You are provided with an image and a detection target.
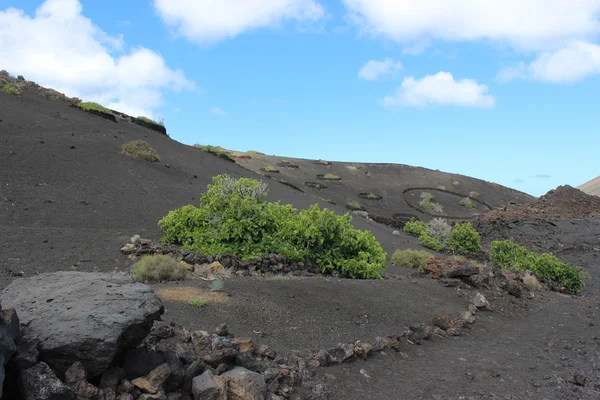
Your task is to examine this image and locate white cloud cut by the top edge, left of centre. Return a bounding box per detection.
[154,0,325,44]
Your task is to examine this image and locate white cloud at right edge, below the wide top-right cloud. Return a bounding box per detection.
[497,42,600,83]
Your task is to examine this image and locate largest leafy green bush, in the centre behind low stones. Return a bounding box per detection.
[158,175,386,278]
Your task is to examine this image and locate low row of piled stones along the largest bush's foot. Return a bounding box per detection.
[121,239,326,276]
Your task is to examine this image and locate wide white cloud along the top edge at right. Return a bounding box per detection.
[342,0,600,50]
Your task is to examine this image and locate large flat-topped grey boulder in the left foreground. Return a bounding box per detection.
[2,271,164,379]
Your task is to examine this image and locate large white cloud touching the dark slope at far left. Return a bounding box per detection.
[0,0,193,116]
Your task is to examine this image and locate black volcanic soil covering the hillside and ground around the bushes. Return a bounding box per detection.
[0,84,600,400]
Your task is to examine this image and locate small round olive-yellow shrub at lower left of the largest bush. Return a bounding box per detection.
[131,254,188,282]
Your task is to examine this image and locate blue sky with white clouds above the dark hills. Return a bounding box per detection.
[0,0,600,196]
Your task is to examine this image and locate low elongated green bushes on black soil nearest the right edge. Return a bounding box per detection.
[490,240,586,293]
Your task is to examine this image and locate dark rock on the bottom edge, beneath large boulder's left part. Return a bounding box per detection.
[20,362,75,400]
